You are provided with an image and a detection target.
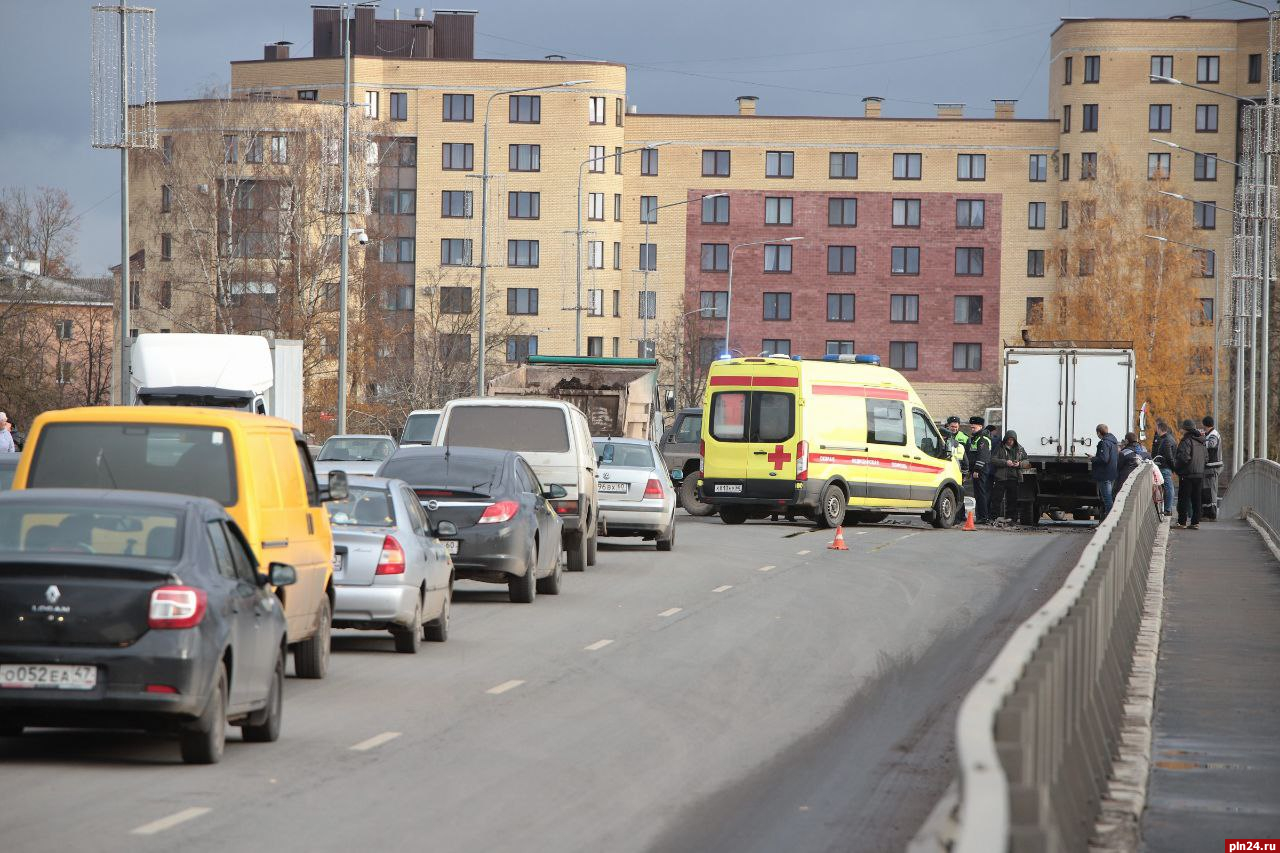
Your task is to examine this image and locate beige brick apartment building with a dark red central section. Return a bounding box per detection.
[122,8,1266,422]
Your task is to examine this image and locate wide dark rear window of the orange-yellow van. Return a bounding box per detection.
[27,424,236,506]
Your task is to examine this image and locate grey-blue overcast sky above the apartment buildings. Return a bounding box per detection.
[0,0,1258,275]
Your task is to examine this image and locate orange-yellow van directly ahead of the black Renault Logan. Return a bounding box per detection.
[13,406,346,679]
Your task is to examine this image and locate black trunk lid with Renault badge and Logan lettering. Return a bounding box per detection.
[0,562,169,646]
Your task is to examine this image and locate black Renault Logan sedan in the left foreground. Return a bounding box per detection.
[0,489,297,765]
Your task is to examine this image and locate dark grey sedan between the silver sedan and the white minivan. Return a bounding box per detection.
[378,446,564,603]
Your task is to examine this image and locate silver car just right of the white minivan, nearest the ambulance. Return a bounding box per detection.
[593,438,676,551]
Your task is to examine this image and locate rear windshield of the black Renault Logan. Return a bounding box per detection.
[0,502,182,562]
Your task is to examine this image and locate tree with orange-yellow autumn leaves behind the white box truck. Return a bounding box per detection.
[1034,152,1220,423]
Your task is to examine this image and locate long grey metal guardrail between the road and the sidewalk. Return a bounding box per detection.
[950,462,1162,853]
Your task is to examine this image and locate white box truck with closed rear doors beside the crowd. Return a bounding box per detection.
[995,341,1137,524]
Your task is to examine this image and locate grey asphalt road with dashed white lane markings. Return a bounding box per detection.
[0,515,1088,853]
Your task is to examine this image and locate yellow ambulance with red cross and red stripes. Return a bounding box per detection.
[699,355,964,528]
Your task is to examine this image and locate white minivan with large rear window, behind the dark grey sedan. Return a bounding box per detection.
[435,397,600,571]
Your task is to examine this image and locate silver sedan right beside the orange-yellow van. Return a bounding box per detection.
[325,476,453,654]
